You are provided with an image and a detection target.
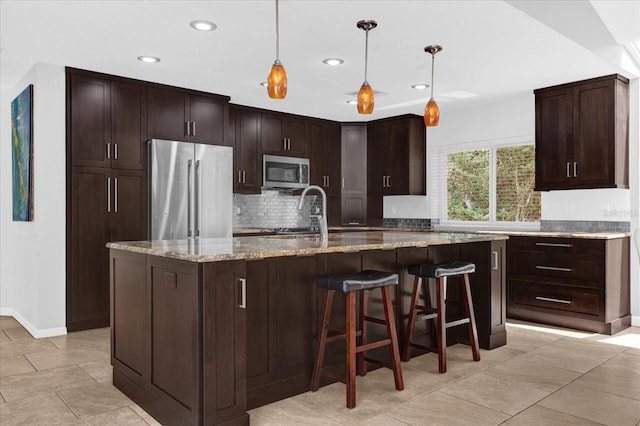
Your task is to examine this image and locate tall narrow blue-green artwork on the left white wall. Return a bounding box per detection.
[11,84,33,221]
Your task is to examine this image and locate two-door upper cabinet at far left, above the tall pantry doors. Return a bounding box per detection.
[67,73,147,170]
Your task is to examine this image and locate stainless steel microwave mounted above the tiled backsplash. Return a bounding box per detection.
[262,155,309,189]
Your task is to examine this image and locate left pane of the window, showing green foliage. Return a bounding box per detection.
[447,149,489,221]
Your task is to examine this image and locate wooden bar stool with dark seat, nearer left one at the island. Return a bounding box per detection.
[311,270,404,408]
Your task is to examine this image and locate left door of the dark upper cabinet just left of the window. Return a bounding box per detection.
[367,123,389,195]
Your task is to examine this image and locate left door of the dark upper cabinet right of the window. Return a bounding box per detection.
[535,88,573,191]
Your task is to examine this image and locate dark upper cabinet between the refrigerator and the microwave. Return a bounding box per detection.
[229,106,262,194]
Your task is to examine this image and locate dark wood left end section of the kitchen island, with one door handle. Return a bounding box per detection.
[110,250,249,425]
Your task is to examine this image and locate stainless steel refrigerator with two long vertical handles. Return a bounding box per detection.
[148,139,233,240]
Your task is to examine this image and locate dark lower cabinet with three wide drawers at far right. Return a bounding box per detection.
[507,237,631,334]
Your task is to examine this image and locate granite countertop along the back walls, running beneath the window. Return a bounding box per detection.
[233,226,630,240]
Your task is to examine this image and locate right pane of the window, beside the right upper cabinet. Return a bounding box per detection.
[496,145,540,222]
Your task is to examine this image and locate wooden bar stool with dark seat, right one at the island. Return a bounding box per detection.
[402,261,480,373]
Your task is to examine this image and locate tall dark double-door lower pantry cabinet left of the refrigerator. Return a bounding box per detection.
[67,167,147,331]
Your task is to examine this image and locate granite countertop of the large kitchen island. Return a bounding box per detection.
[107,231,508,263]
